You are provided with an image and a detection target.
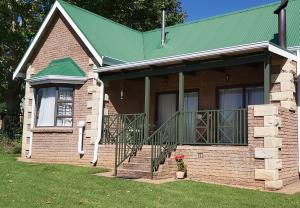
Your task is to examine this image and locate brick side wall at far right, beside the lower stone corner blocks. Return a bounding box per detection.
[279,107,299,185]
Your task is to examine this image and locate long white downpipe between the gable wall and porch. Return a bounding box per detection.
[91,73,104,165]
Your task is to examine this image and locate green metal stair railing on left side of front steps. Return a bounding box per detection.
[109,113,145,175]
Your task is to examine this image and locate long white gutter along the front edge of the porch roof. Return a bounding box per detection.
[95,41,269,73]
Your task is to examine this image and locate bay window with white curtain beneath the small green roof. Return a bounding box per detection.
[36,87,73,127]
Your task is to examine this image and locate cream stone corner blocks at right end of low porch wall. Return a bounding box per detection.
[254,104,283,190]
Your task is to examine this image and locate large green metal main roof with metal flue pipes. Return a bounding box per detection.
[58,0,300,62]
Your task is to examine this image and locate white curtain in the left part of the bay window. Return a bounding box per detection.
[37,87,56,126]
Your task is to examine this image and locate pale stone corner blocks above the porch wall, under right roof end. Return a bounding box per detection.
[270,59,296,111]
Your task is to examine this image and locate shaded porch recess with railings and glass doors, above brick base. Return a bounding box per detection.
[102,51,270,178]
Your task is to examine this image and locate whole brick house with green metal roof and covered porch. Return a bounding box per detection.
[14,0,300,190]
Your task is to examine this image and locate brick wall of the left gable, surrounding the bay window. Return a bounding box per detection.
[24,15,114,167]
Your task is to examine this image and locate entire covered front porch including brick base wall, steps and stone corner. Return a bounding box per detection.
[96,46,294,188]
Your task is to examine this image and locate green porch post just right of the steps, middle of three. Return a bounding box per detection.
[178,72,184,144]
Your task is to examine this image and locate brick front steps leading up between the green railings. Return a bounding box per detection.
[117,146,176,179]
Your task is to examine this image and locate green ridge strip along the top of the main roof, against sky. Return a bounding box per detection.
[144,0,286,33]
